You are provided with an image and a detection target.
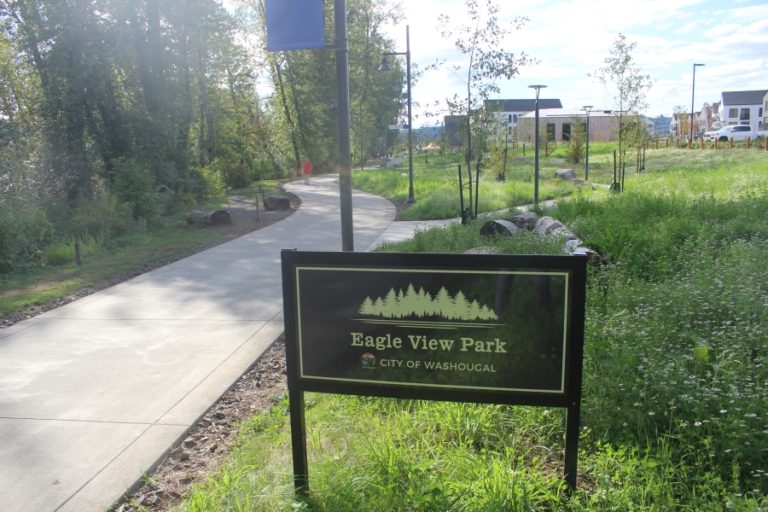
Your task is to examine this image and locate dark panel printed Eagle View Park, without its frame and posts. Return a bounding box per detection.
[295,265,570,394]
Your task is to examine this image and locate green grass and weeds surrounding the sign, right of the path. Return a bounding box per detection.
[172,149,768,512]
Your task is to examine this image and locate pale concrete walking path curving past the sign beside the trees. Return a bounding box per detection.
[0,176,448,512]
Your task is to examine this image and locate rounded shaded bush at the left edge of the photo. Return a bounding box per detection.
[0,200,53,272]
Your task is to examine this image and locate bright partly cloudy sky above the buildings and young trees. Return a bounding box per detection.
[225,0,768,126]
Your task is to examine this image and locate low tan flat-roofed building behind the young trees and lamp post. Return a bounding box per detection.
[517,108,619,142]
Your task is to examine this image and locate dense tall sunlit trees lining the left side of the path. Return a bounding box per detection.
[0,0,404,270]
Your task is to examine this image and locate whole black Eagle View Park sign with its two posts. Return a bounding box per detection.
[282,251,586,488]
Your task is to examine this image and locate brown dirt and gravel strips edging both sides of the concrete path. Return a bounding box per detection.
[0,194,300,512]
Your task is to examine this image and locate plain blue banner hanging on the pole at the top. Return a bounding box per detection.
[265,0,325,52]
